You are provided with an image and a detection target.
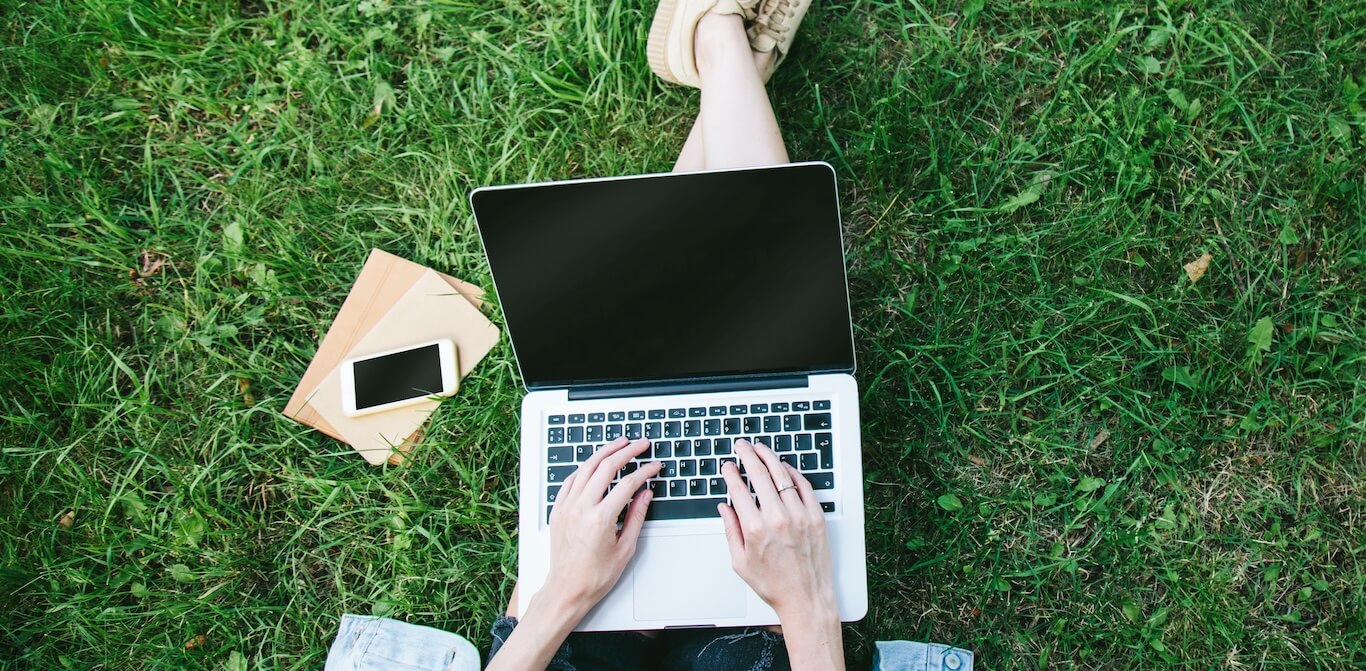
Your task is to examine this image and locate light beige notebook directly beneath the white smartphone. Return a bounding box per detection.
[307,271,499,465]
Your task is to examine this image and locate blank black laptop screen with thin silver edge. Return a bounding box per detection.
[471,163,854,388]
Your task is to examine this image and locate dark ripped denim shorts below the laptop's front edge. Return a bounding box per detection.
[489,616,792,671]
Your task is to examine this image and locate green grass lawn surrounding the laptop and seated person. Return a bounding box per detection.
[0,0,1366,670]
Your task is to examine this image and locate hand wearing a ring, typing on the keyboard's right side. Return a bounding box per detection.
[717,440,839,620]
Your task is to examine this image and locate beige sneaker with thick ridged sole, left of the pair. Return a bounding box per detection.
[645,0,759,87]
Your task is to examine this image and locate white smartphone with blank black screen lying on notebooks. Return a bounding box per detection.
[342,340,460,417]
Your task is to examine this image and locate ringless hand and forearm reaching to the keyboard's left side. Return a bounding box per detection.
[486,439,660,671]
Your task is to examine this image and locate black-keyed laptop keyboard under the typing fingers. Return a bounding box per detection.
[545,399,835,519]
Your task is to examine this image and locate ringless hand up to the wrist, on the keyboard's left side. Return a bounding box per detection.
[545,437,661,610]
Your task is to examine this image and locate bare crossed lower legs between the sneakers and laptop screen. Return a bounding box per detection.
[673,14,788,172]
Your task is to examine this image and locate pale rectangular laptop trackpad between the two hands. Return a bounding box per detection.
[634,533,750,620]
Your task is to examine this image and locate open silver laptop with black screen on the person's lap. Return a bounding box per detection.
[470,163,867,631]
